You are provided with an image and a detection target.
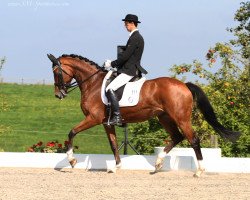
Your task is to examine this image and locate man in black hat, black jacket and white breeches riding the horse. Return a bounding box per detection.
[104,14,147,125]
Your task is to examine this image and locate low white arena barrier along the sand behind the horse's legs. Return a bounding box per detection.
[0,147,250,173]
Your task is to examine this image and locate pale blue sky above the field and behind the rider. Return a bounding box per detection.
[0,0,242,83]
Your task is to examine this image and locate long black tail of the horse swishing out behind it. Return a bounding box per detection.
[186,82,240,142]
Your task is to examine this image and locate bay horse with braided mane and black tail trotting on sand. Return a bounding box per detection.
[48,54,240,177]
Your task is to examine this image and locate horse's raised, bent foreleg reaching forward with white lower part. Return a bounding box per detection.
[67,116,98,168]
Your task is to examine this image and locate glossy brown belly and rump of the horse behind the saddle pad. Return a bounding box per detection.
[121,77,193,122]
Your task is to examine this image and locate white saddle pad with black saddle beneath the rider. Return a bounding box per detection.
[101,71,146,107]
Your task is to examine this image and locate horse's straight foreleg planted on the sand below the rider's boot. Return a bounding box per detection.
[104,125,121,172]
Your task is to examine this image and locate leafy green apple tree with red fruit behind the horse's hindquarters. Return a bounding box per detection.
[132,2,250,156]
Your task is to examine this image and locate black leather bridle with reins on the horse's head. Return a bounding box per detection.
[52,61,102,95]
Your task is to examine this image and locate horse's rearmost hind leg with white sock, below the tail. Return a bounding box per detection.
[180,122,205,177]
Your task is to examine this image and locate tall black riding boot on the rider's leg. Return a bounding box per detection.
[107,89,122,126]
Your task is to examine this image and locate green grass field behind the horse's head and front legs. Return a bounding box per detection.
[0,83,133,154]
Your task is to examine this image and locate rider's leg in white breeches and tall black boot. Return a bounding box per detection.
[106,73,133,126]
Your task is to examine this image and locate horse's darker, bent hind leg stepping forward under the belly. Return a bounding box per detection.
[155,114,184,171]
